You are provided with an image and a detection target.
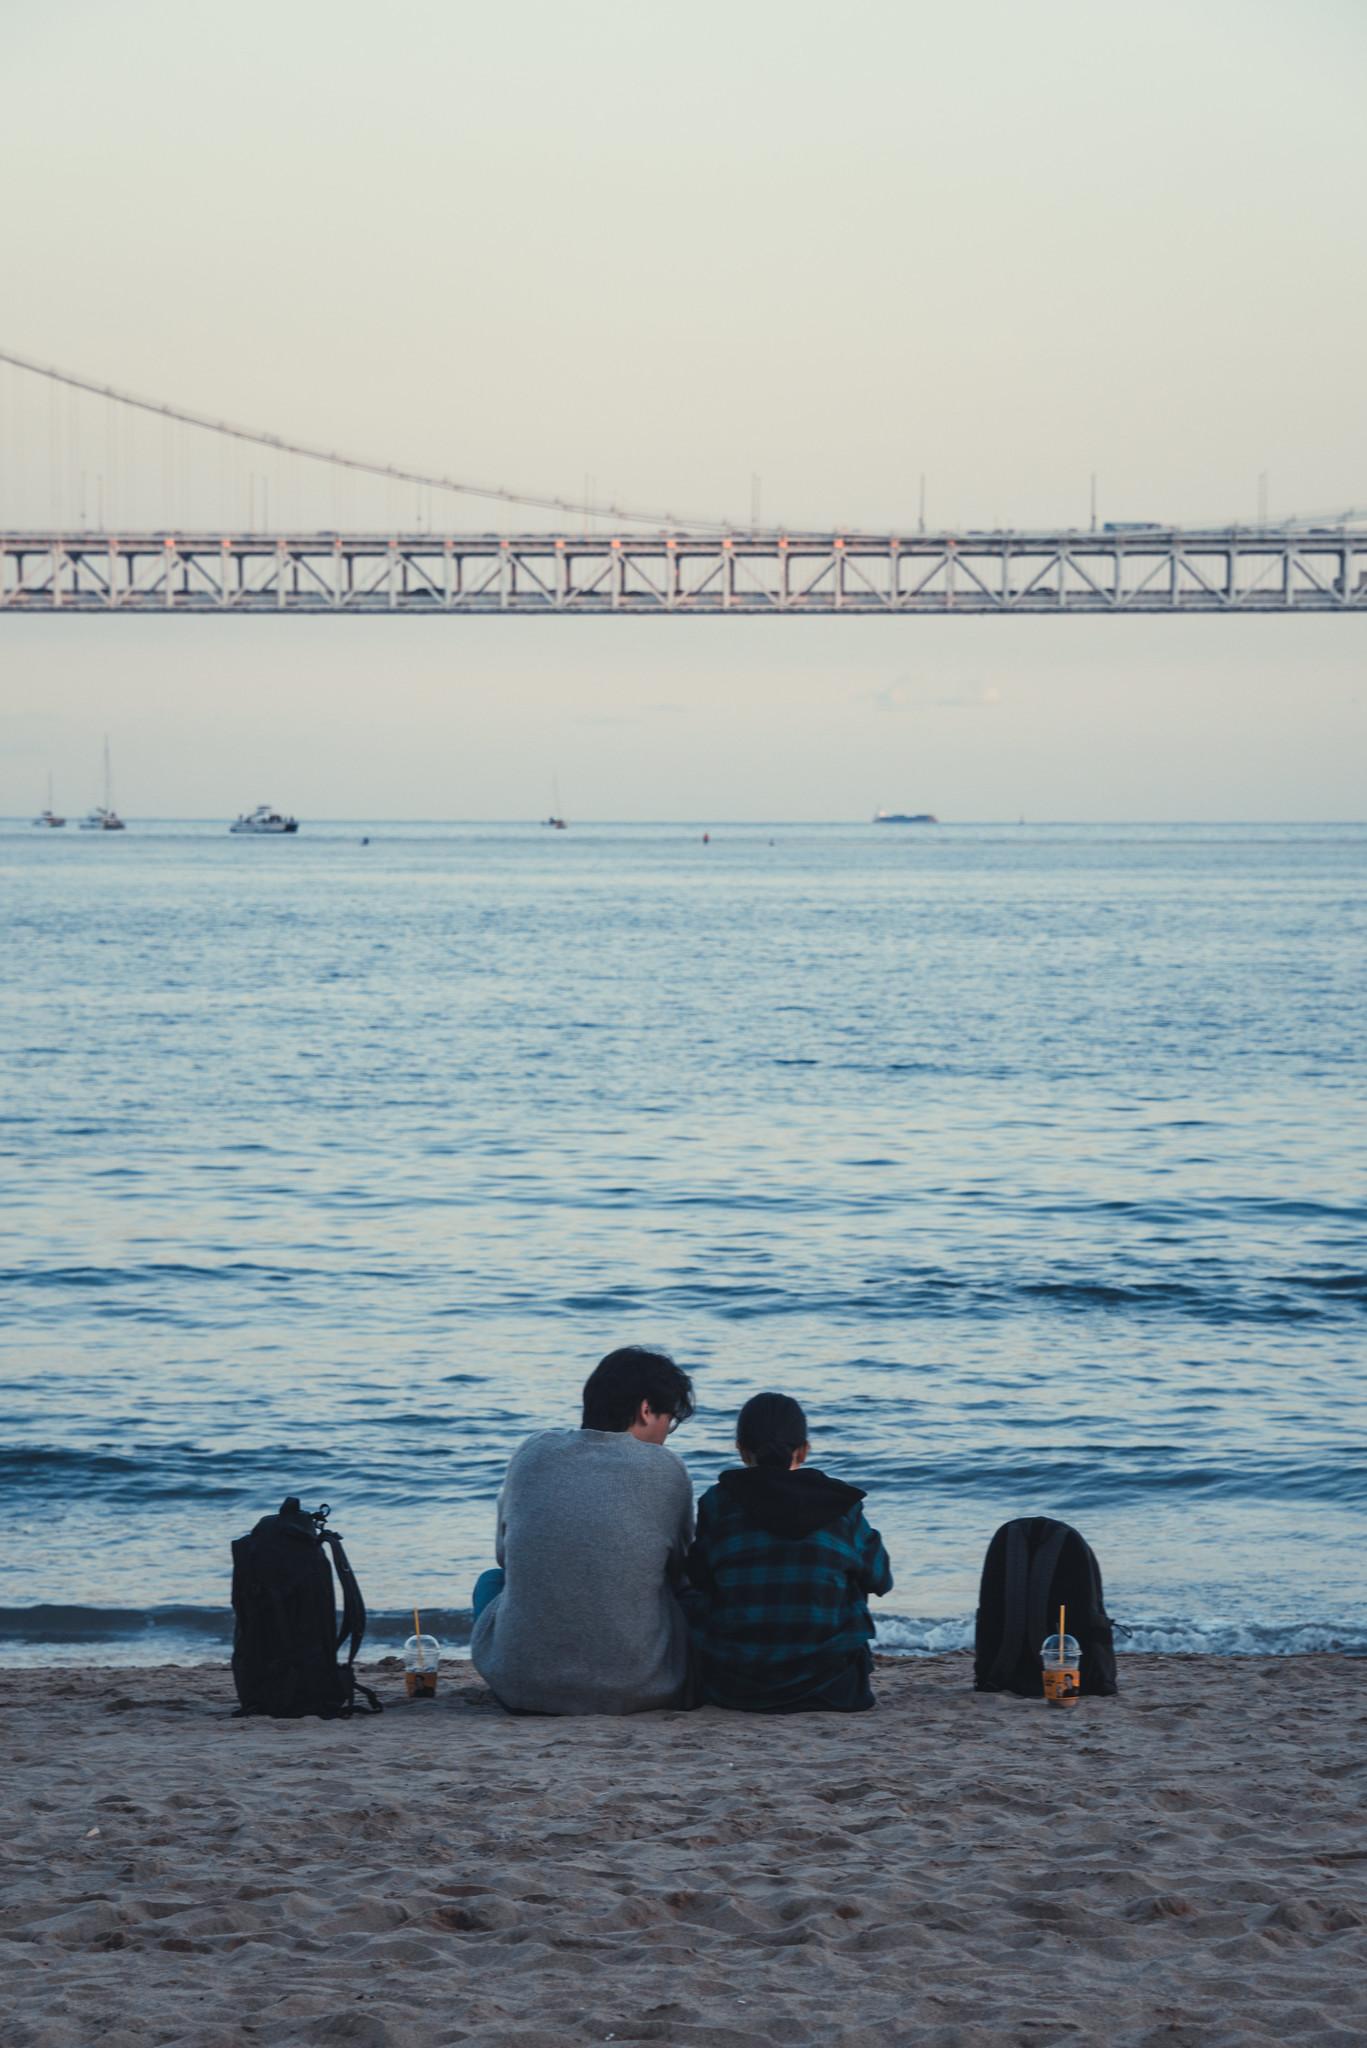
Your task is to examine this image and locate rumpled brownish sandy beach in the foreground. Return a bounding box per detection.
[0,1657,1367,2048]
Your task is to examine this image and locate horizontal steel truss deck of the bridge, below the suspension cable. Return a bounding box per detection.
[0,528,1367,618]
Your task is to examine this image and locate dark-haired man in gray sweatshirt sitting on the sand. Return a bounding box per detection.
[469,1346,693,1714]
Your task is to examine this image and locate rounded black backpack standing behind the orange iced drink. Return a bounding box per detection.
[974,1516,1119,1700]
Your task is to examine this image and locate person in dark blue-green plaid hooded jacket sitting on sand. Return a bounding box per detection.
[687,1395,892,1714]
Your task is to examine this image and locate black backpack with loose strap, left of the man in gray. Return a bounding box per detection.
[232,1493,381,1720]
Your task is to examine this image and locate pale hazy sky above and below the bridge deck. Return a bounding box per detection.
[0,0,1367,819]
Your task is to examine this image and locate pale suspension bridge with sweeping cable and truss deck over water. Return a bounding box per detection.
[0,350,1367,618]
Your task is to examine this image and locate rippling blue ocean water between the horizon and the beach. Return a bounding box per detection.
[0,821,1367,1663]
